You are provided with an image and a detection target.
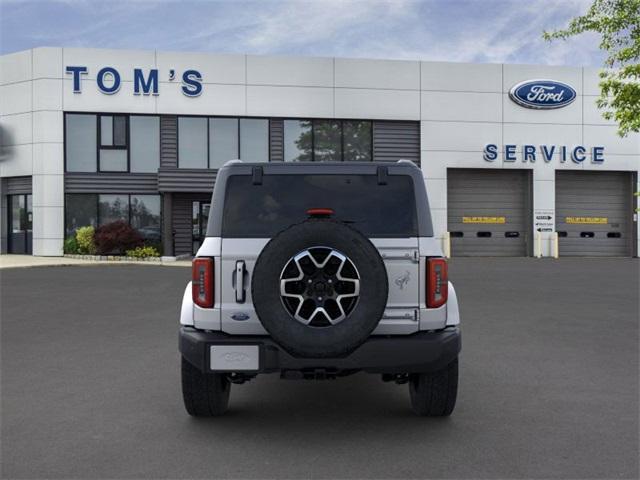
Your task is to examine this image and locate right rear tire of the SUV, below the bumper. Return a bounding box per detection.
[409,357,458,417]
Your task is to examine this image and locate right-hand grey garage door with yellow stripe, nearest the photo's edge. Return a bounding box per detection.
[556,171,633,257]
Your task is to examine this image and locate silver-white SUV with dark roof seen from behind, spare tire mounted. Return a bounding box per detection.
[180,161,461,416]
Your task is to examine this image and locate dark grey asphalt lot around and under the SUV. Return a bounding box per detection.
[0,259,640,479]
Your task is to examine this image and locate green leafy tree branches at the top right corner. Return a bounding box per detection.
[543,0,640,136]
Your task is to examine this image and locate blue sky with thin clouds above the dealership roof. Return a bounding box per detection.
[0,0,604,66]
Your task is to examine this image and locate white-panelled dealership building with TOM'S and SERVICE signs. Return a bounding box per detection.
[0,48,640,257]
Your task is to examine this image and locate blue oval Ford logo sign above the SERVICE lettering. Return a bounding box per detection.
[509,80,576,110]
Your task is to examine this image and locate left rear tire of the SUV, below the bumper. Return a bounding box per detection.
[182,357,231,417]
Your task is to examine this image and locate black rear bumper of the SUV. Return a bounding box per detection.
[180,327,461,374]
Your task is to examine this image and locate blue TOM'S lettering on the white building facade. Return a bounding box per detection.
[65,65,202,97]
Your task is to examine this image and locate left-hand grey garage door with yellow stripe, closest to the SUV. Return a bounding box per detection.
[447,169,531,257]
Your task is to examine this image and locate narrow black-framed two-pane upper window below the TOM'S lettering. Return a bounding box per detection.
[99,115,128,172]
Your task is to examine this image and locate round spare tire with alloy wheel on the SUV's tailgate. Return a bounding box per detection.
[251,219,388,358]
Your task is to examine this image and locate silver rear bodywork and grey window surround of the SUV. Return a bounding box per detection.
[180,162,460,342]
